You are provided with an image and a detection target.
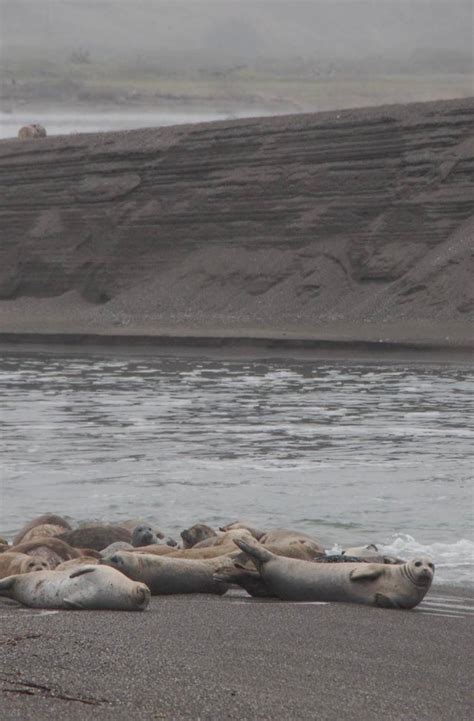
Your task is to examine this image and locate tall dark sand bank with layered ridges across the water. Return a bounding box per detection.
[0,99,474,347]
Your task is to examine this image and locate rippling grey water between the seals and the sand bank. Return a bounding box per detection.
[0,351,474,584]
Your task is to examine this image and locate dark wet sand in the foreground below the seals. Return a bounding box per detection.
[0,587,474,721]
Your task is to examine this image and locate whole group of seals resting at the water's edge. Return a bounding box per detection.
[0,514,434,610]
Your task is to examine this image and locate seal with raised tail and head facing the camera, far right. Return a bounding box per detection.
[236,540,434,608]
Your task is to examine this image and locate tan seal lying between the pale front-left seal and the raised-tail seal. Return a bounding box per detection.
[100,551,232,595]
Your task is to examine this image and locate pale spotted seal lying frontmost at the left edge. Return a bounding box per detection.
[0,566,150,611]
